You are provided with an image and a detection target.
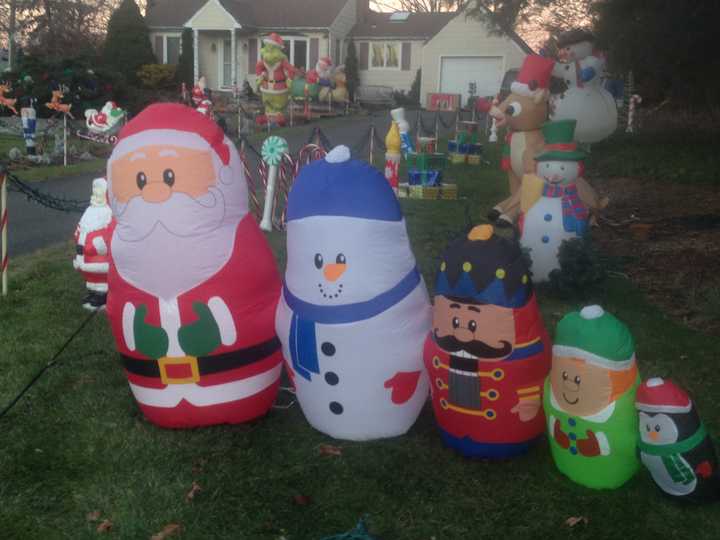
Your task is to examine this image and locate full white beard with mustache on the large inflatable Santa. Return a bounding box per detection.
[111,188,239,300]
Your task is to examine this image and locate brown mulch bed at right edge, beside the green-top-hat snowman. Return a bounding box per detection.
[593,178,720,335]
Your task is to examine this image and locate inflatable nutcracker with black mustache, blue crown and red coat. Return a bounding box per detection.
[424,225,551,458]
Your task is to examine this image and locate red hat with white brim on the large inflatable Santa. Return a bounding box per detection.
[113,103,230,166]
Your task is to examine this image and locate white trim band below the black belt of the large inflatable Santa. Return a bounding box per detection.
[129,364,282,408]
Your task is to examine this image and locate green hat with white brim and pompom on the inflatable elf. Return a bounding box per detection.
[553,306,635,371]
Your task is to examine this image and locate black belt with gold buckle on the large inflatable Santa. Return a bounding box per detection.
[120,336,280,384]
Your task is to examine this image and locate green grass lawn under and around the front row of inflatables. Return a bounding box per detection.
[0,130,720,540]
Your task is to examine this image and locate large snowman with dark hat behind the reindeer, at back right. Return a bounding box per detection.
[550,30,617,143]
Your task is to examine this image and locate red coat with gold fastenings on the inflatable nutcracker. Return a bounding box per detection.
[423,296,552,444]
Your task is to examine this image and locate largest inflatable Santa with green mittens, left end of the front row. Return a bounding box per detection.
[107,103,282,428]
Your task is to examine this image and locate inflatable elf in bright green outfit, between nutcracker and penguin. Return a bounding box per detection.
[543,306,640,489]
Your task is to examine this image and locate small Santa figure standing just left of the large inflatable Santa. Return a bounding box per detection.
[73,178,114,311]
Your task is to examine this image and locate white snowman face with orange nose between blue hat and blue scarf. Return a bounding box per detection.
[285,216,415,306]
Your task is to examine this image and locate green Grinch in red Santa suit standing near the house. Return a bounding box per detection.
[255,32,295,125]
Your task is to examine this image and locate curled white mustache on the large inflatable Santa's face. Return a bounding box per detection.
[110,187,225,242]
